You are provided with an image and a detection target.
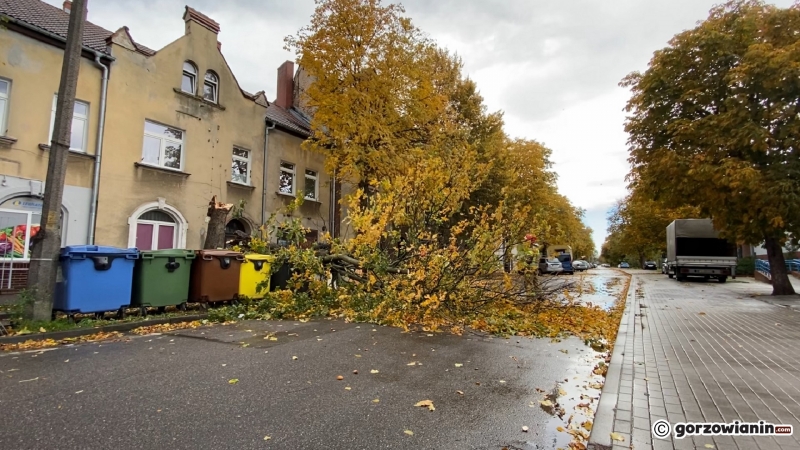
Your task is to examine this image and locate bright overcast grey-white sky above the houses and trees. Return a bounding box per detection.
[46,0,791,250]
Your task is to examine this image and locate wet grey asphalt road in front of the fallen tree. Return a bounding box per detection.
[0,272,624,450]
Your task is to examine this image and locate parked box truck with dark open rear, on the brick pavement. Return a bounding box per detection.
[666,219,737,283]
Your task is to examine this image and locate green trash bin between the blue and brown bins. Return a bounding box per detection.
[131,249,195,316]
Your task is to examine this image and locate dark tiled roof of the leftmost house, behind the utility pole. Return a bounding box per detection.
[0,0,155,56]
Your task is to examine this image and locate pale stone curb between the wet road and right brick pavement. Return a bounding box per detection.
[587,275,636,450]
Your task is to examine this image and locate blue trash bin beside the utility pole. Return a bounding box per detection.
[53,245,139,317]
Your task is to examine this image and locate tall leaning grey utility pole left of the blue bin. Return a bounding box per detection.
[28,0,87,321]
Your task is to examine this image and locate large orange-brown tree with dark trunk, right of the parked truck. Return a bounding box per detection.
[622,0,800,294]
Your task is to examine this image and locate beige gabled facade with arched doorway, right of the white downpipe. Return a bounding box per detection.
[97,9,329,248]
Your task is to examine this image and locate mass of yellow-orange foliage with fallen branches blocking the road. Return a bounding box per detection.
[241,0,610,334]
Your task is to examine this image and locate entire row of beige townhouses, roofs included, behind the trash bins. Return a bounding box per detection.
[0,0,333,296]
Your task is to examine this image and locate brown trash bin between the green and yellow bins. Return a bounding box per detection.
[189,250,244,303]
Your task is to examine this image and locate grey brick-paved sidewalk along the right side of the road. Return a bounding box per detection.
[590,273,800,450]
